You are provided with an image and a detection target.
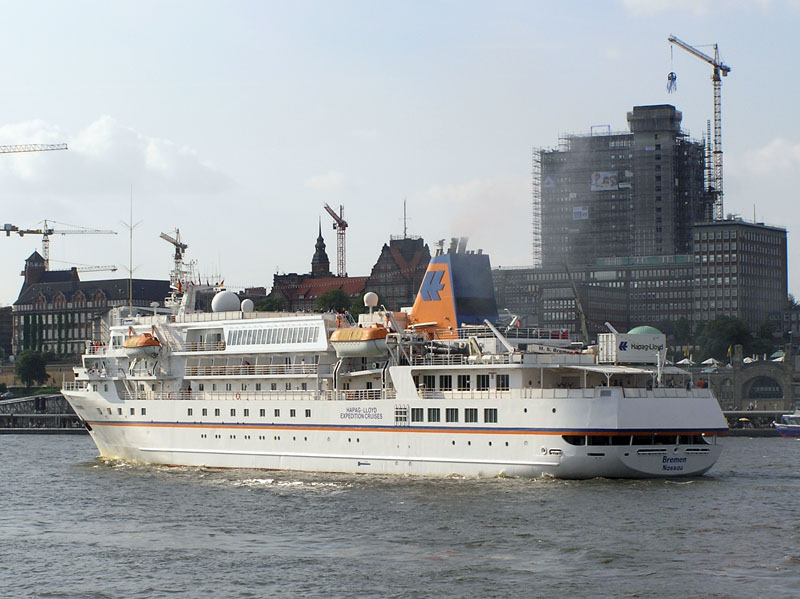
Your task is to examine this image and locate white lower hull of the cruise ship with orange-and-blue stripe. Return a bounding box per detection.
[64,391,721,479]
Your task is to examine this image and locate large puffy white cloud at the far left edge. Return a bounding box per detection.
[0,116,235,195]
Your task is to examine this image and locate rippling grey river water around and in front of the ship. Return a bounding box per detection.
[0,435,800,599]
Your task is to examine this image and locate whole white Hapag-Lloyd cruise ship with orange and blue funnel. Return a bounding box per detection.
[62,239,728,478]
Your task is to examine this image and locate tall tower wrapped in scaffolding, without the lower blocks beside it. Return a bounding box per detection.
[534,105,714,267]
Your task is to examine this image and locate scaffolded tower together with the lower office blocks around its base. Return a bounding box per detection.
[494,105,787,336]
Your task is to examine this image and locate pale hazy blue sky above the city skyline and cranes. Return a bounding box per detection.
[0,0,800,306]
